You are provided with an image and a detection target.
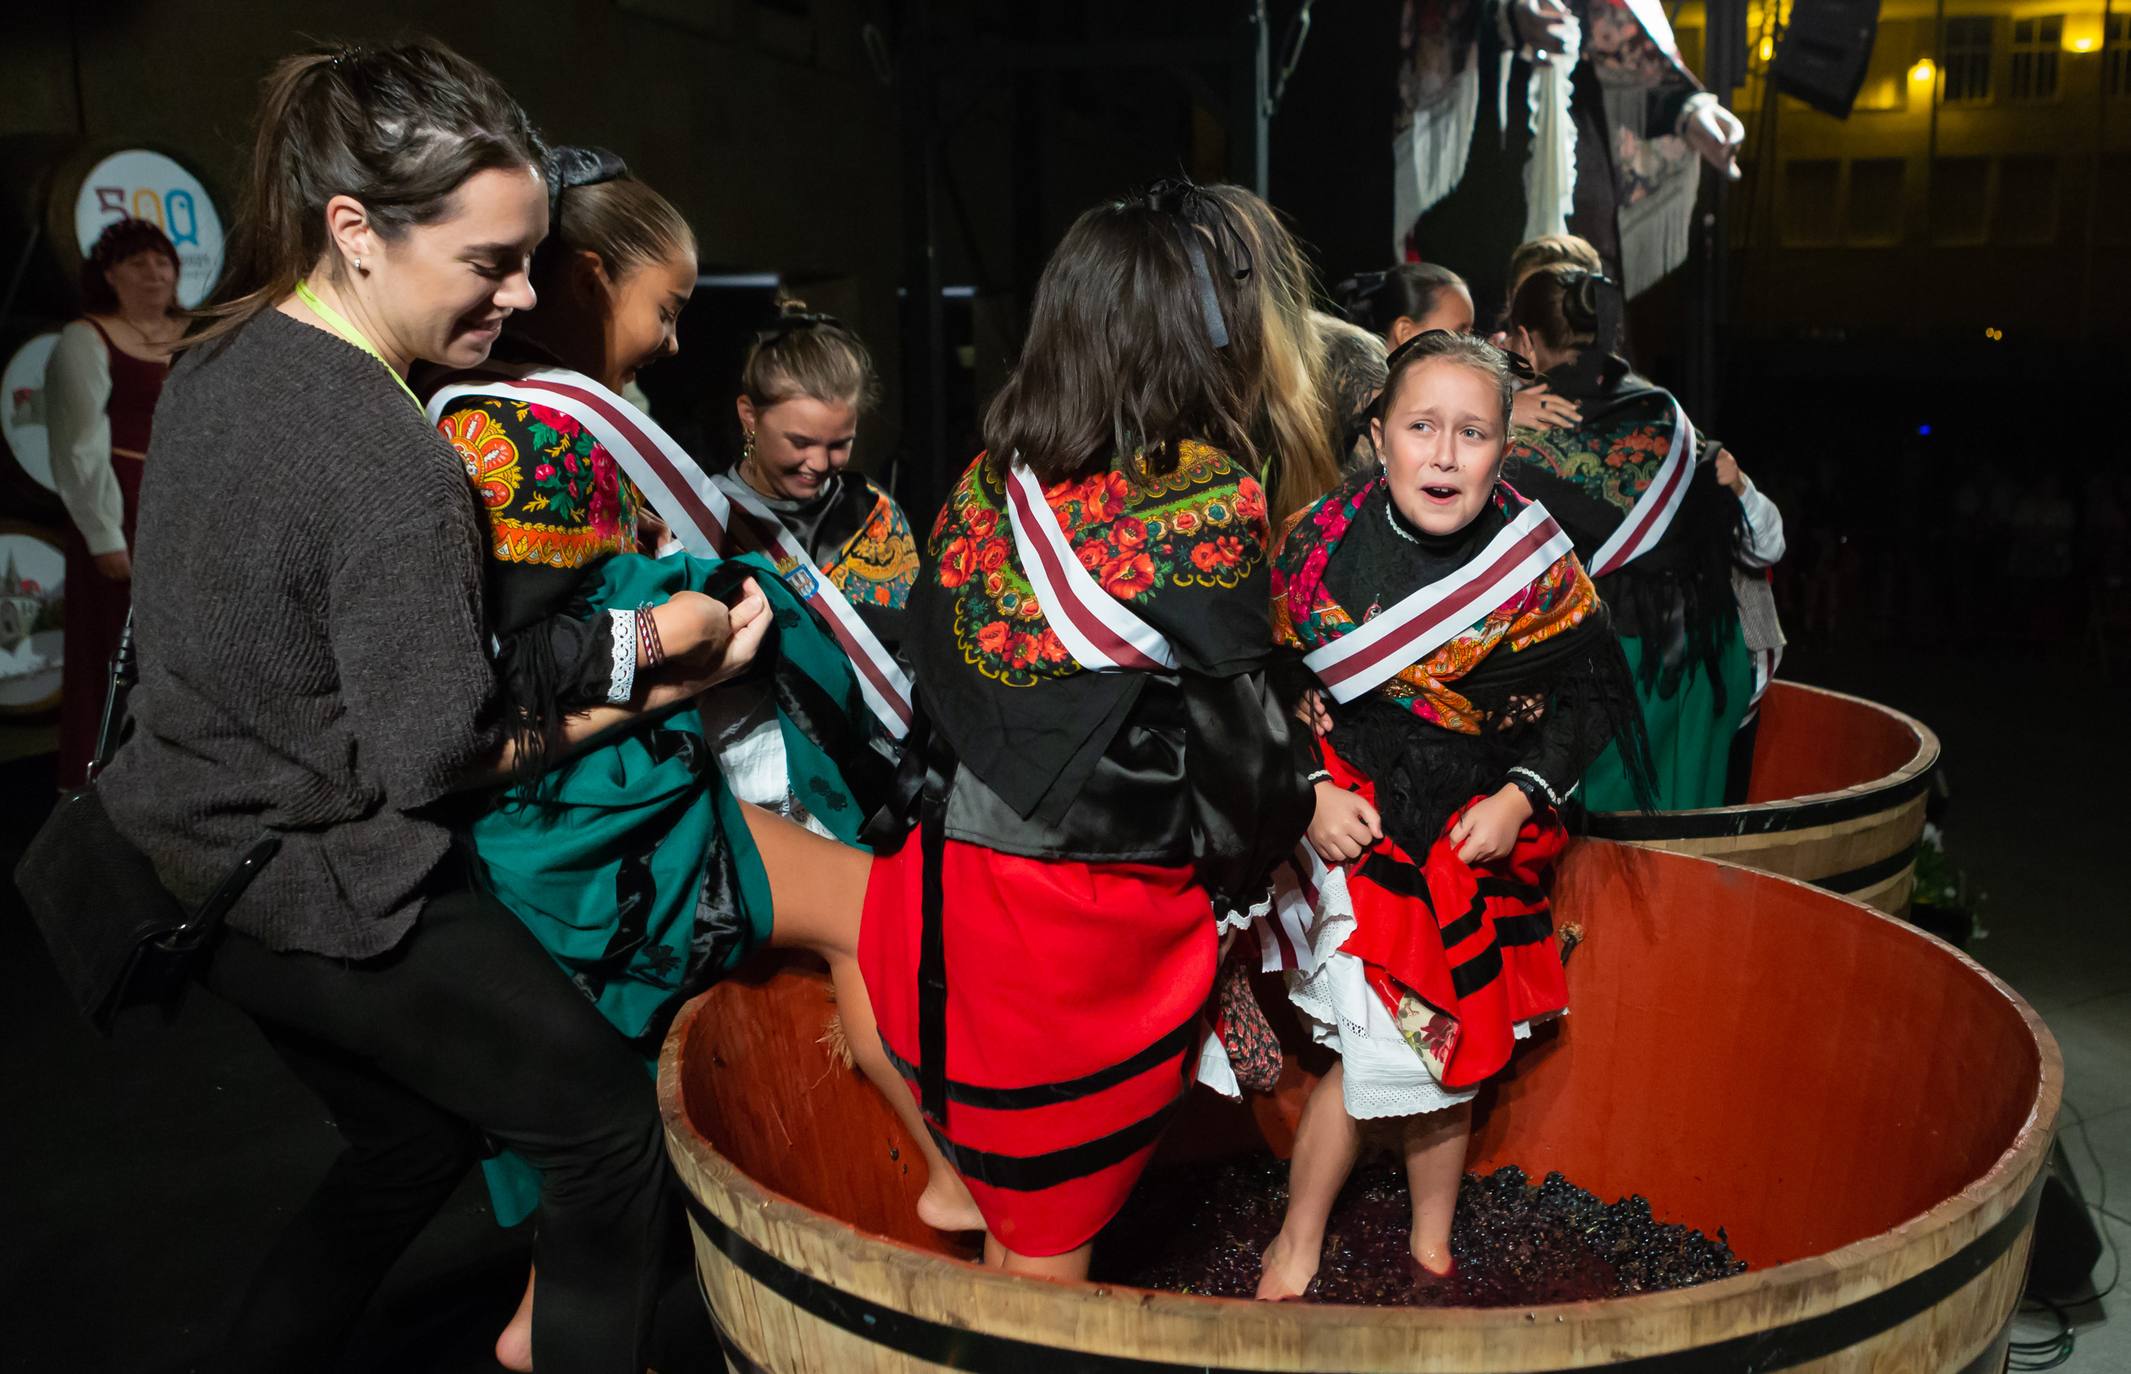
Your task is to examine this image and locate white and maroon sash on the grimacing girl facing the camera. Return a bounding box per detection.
[1302,501,1575,703]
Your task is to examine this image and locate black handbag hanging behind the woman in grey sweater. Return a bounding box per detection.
[15,616,281,1035]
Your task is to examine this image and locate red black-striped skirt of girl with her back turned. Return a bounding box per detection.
[859,835,1217,1255]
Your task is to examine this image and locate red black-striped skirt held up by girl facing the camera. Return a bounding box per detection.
[1323,748,1568,1089]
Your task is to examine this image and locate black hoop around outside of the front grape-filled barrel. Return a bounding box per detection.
[688,1172,2044,1374]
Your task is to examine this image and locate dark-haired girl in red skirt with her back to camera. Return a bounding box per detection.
[848,185,1311,1278]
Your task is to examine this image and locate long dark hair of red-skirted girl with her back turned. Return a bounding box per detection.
[985,196,1264,484]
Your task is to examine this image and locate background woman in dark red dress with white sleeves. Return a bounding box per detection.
[45,219,185,790]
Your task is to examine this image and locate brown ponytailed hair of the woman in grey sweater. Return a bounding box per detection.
[192,38,541,343]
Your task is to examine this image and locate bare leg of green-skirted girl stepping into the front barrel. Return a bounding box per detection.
[742,803,985,1231]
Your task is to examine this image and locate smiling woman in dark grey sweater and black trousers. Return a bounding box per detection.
[100,45,767,1374]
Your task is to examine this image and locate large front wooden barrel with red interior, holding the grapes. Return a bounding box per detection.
[658,841,2063,1374]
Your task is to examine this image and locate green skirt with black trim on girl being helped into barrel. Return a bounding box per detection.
[473,554,872,1225]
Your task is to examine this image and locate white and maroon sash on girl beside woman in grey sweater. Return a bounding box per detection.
[428,364,912,737]
